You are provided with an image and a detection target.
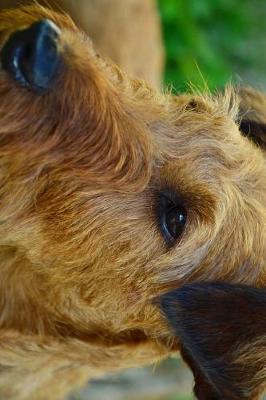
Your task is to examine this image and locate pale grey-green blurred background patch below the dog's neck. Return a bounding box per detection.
[68,358,194,400]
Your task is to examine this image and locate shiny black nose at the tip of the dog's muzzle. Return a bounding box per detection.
[0,20,60,92]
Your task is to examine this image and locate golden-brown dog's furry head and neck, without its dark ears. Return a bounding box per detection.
[0,3,266,400]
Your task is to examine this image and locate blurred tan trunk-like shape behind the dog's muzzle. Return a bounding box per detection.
[0,0,164,88]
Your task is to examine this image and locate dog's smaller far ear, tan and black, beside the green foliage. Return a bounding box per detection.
[238,88,266,149]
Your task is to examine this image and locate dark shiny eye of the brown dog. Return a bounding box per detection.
[157,193,187,245]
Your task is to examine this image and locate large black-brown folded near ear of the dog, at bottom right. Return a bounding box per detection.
[161,283,266,400]
